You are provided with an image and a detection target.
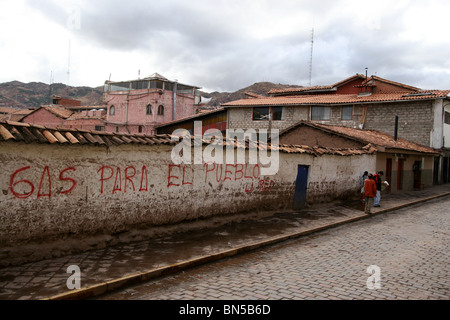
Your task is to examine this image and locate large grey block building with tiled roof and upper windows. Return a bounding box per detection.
[222,75,450,184]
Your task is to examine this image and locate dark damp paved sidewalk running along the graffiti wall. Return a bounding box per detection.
[0,184,450,300]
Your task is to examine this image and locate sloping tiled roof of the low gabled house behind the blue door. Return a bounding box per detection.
[280,121,439,155]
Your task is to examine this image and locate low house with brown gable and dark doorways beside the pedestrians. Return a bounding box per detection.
[280,121,439,192]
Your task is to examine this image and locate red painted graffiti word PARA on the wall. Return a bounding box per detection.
[97,165,148,194]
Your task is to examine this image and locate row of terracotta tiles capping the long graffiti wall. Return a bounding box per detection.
[0,121,376,156]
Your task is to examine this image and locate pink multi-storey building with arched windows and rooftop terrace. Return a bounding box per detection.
[103,73,200,135]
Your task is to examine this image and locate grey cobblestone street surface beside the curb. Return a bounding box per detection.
[99,197,450,300]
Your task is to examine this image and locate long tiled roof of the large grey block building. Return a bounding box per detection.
[222,90,450,107]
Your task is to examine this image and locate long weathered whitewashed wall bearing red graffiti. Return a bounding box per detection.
[0,142,375,264]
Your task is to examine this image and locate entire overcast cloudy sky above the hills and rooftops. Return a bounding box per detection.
[0,0,450,92]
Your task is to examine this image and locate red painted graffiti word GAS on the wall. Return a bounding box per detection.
[9,166,77,199]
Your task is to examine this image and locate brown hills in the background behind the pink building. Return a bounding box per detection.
[0,81,298,109]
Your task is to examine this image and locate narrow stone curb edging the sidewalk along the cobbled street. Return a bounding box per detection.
[42,192,450,300]
